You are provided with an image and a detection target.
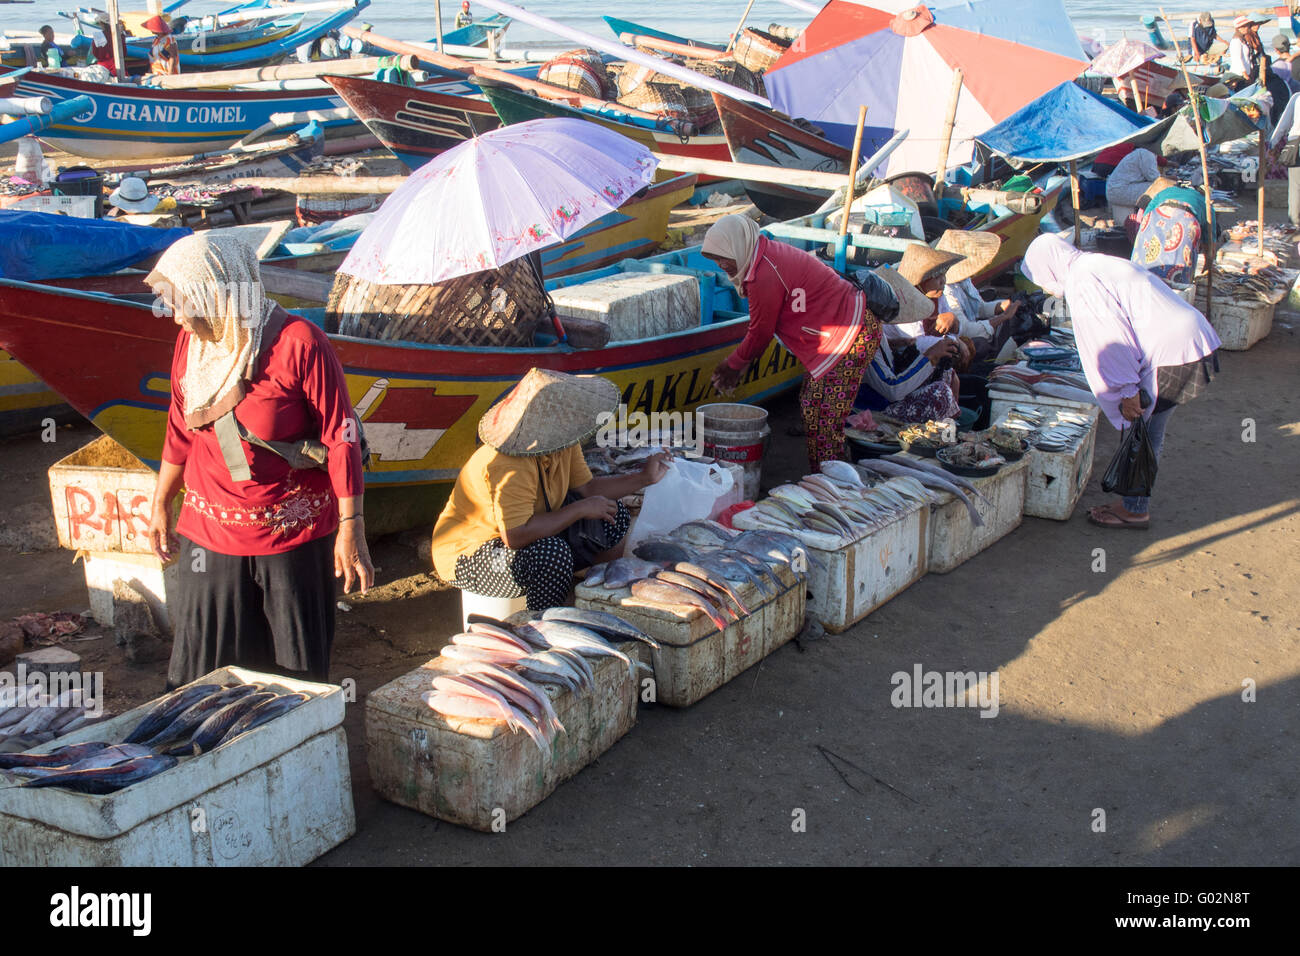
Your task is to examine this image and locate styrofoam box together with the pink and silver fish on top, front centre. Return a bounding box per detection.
[365,607,647,832]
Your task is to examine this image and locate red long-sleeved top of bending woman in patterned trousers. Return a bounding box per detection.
[727,235,863,378]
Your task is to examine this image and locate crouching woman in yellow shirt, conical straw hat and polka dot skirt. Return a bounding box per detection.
[433,368,667,611]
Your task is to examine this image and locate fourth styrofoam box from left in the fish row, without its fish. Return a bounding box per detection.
[732,494,930,633]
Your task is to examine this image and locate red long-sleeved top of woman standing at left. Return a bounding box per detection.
[163,310,364,555]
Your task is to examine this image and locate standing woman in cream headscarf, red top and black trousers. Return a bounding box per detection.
[146,235,374,687]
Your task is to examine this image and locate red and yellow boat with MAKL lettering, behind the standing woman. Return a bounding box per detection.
[0,247,801,533]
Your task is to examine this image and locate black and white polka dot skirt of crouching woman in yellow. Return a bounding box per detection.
[452,503,632,611]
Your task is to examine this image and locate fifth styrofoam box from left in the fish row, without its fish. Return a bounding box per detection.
[927,458,1030,574]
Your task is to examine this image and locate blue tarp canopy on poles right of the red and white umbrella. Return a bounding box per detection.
[975,82,1173,163]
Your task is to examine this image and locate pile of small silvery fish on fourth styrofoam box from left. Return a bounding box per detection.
[745,462,933,546]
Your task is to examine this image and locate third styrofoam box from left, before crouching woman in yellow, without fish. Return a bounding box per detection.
[575,568,807,708]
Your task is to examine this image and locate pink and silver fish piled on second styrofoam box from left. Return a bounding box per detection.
[421,607,659,753]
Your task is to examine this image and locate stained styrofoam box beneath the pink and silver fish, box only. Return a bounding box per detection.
[365,644,637,831]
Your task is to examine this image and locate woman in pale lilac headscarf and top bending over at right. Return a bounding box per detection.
[1021,235,1219,529]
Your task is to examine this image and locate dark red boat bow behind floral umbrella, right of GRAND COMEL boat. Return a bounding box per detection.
[324,77,501,169]
